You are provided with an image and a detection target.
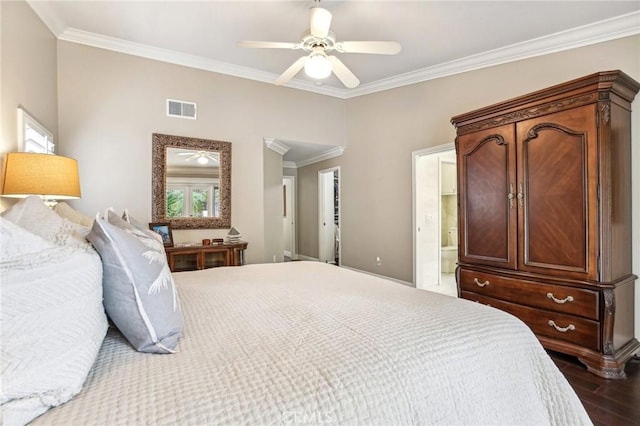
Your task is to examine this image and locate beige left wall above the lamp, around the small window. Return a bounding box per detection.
[0,1,60,210]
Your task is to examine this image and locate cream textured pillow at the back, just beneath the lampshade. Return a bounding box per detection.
[1,196,91,250]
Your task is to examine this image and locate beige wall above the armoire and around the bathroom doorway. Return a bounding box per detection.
[341,36,640,281]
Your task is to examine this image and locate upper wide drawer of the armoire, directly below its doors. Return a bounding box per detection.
[459,269,600,320]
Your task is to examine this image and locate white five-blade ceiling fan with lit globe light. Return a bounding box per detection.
[238,6,402,89]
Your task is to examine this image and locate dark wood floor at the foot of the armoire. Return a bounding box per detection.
[549,352,640,426]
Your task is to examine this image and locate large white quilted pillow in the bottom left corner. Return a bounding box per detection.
[0,217,108,425]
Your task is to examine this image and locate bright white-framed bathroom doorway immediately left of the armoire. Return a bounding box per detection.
[412,144,458,296]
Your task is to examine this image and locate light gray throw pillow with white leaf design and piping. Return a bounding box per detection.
[87,217,183,353]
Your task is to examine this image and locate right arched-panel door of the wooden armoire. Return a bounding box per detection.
[517,105,597,278]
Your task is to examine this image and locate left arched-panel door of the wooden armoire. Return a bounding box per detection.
[458,125,516,268]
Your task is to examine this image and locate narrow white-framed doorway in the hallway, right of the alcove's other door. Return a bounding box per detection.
[318,166,341,265]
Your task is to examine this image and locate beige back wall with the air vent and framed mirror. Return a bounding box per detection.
[58,42,346,263]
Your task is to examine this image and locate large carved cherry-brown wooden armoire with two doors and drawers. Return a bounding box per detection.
[451,71,640,378]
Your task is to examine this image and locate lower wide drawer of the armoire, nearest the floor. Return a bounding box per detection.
[462,291,600,351]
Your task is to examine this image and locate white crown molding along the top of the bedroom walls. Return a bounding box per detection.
[27,0,640,99]
